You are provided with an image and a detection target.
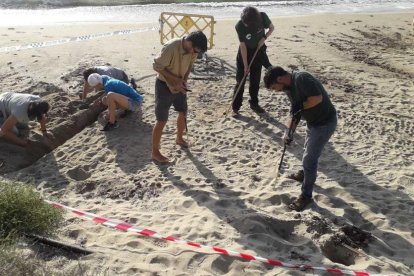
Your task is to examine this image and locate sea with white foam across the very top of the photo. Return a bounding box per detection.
[0,0,414,26]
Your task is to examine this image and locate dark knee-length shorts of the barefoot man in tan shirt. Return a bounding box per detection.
[155,78,187,122]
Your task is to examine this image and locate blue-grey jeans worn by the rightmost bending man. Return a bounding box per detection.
[302,116,337,198]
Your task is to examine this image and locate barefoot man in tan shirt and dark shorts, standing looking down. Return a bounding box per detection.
[152,31,207,163]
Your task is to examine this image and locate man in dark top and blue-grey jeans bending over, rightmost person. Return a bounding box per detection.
[264,66,337,211]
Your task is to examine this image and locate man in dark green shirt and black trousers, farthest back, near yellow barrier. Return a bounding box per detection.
[232,7,274,116]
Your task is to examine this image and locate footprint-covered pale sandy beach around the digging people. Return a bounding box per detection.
[0,11,414,275]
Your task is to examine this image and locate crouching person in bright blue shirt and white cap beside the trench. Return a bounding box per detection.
[88,73,143,131]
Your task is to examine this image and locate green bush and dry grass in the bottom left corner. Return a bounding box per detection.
[0,182,73,275]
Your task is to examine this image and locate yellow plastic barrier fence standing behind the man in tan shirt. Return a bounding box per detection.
[159,12,216,49]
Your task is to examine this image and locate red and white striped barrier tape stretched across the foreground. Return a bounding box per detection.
[45,200,373,276]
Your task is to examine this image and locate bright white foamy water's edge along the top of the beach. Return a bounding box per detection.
[0,3,414,27]
